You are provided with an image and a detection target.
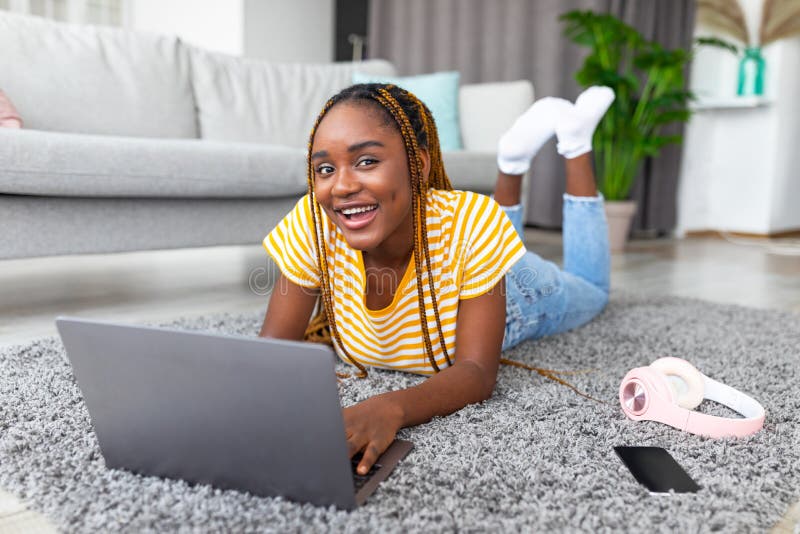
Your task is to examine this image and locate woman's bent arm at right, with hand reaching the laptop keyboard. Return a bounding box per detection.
[344,279,506,473]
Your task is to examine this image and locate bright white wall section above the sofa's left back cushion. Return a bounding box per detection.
[127,0,244,55]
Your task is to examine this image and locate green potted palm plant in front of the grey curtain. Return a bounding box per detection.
[560,10,692,251]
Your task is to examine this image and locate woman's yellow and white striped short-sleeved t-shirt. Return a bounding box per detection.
[264,189,525,375]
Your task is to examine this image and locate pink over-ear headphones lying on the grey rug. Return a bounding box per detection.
[619,358,764,438]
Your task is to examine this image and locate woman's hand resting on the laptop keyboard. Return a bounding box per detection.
[342,396,403,475]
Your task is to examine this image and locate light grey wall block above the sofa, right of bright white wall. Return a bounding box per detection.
[244,0,335,63]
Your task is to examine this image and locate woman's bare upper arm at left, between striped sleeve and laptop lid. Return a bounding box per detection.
[258,273,319,341]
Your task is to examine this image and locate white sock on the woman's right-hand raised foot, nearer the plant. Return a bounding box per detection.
[556,85,614,159]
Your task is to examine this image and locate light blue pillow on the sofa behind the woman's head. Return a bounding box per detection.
[353,71,462,150]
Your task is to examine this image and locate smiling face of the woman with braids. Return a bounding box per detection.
[311,102,429,256]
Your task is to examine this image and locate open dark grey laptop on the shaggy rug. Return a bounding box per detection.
[56,317,413,510]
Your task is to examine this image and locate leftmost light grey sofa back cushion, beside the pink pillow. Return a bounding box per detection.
[0,11,197,137]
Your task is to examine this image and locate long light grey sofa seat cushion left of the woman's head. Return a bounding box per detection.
[0,129,306,198]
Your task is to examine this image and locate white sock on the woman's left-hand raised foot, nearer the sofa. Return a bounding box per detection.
[497,97,572,174]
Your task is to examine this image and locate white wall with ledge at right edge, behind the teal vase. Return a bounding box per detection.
[676,24,800,235]
